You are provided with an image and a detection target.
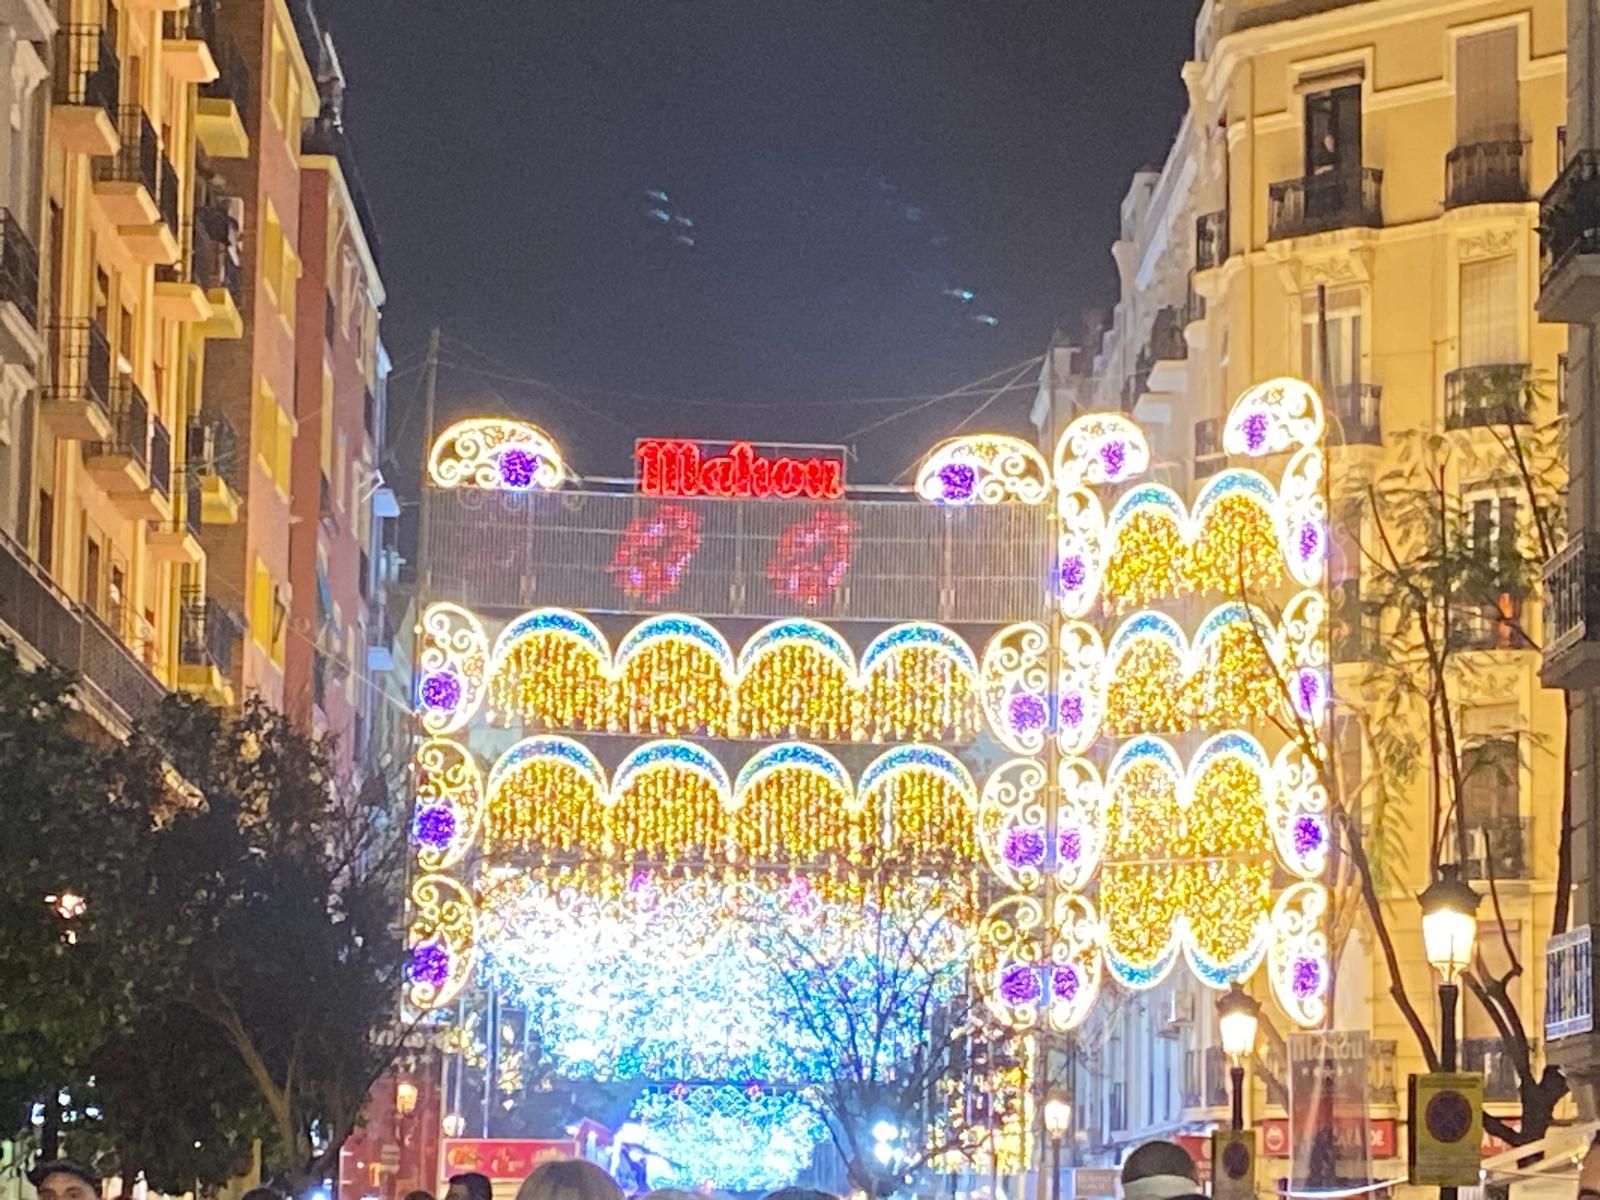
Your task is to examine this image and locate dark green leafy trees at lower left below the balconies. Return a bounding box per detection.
[0,659,403,1190]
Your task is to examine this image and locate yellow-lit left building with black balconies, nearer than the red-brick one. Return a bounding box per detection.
[26,0,240,729]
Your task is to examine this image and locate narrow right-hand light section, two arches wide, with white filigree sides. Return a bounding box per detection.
[978,379,1331,1029]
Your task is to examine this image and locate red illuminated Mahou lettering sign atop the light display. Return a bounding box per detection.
[634,438,845,499]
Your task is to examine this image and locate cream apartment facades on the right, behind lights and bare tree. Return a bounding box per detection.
[1056,0,1568,1178]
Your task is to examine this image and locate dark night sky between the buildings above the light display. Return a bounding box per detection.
[318,0,1197,480]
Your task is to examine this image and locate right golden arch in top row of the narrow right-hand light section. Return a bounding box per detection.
[1189,467,1285,595]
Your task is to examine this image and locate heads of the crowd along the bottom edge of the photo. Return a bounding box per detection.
[18,1134,1600,1200]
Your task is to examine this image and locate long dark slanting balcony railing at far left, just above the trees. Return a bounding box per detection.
[0,533,166,723]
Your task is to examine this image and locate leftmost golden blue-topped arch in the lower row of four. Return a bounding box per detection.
[483,734,610,853]
